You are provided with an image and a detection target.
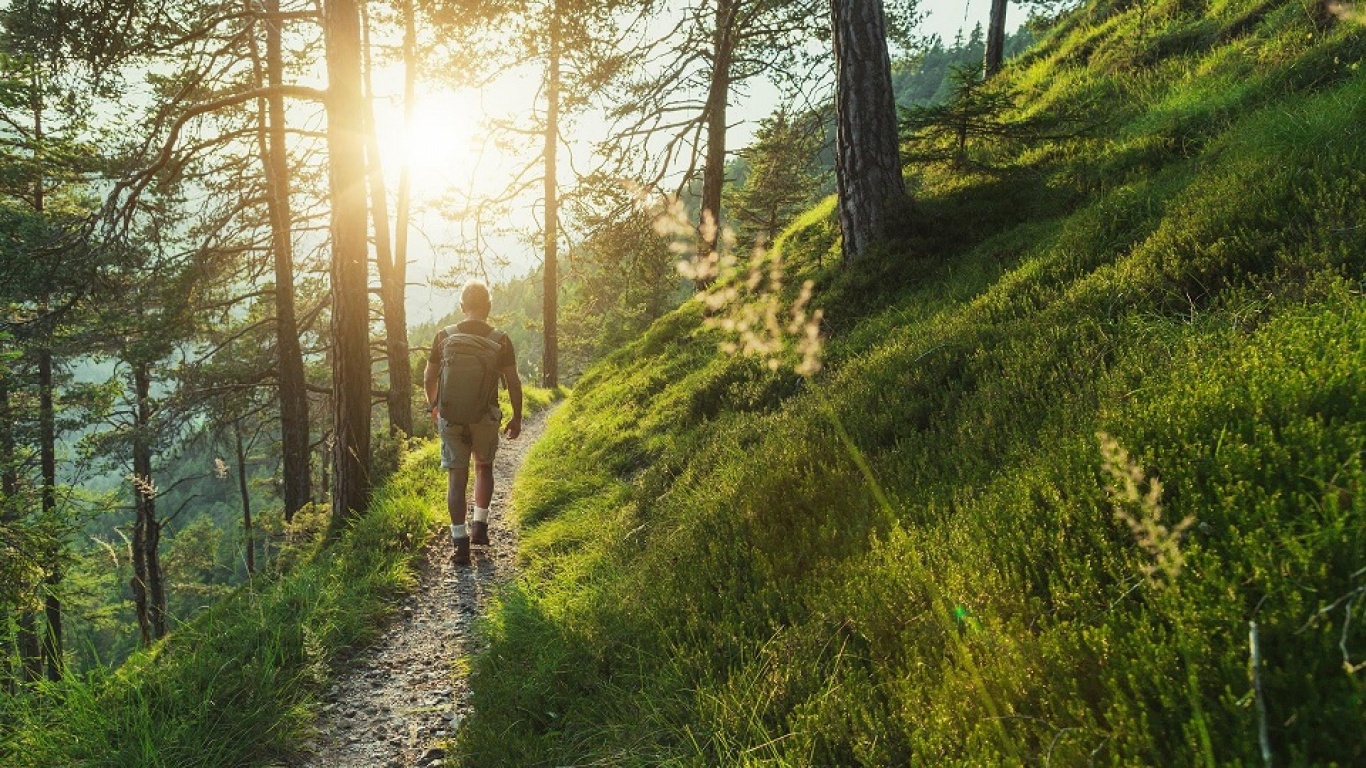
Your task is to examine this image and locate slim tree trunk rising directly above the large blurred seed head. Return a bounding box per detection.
[697,0,736,290]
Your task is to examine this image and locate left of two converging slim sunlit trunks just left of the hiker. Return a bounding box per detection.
[361,0,413,436]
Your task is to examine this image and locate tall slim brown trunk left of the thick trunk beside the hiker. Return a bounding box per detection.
[261,0,311,521]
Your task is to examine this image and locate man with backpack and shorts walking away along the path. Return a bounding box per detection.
[423,280,522,566]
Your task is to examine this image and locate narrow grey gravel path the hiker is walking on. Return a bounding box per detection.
[296,410,549,768]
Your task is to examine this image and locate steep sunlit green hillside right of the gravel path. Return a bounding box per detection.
[456,0,1366,765]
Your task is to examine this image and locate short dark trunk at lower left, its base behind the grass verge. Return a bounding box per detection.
[133,362,167,645]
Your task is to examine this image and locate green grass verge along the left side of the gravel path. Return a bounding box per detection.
[0,388,557,768]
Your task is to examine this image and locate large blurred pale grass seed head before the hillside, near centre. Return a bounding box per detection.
[654,198,825,379]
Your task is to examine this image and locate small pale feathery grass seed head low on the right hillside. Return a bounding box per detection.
[1096,432,1195,586]
